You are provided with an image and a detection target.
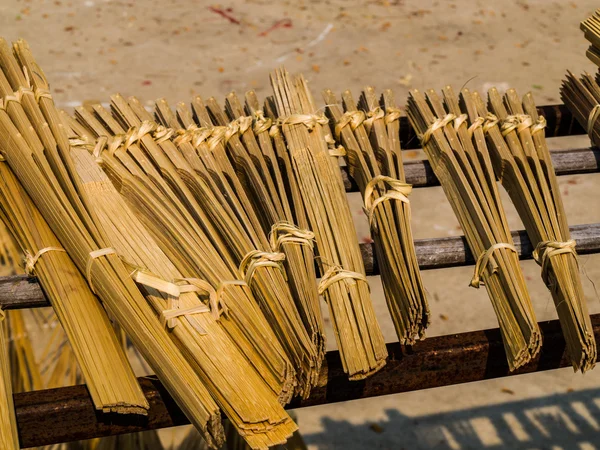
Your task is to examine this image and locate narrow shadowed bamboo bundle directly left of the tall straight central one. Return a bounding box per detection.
[206,91,325,366]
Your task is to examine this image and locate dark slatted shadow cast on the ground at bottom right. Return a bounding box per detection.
[304,389,600,450]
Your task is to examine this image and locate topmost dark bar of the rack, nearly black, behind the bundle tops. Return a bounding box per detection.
[400,105,586,150]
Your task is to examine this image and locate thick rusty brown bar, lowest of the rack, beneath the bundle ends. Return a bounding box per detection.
[15,315,600,447]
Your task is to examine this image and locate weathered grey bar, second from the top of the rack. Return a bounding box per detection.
[341,148,600,192]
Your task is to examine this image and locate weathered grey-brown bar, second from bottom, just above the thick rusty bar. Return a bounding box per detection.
[0,223,600,310]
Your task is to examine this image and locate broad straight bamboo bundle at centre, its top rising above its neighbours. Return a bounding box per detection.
[271,70,387,380]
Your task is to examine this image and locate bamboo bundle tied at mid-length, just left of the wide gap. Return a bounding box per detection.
[323,87,430,344]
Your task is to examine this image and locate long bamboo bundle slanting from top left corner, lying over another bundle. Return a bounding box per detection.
[0,41,223,446]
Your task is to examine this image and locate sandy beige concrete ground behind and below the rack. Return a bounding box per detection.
[0,0,600,450]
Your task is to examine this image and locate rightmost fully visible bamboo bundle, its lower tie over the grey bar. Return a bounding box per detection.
[480,89,597,372]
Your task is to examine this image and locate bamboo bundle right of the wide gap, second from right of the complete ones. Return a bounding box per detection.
[407,86,541,370]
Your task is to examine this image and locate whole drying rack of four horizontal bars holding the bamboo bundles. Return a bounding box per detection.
[0,105,600,448]
